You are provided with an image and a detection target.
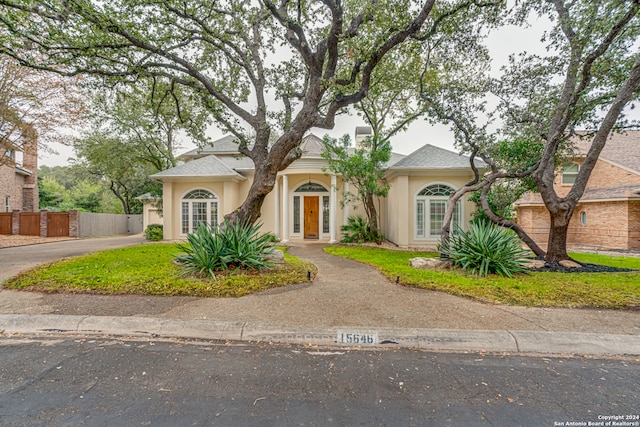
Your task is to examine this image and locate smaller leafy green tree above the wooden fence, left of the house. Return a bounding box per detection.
[74,79,209,214]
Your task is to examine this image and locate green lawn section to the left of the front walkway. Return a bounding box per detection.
[3,243,315,297]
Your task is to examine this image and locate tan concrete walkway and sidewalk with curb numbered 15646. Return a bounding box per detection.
[0,241,640,355]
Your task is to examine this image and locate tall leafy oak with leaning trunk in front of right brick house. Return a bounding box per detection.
[493,0,640,262]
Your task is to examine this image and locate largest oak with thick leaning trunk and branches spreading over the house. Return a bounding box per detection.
[0,0,496,226]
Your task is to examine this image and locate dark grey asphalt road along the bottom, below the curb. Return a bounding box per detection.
[0,336,640,427]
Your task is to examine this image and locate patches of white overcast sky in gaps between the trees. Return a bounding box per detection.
[39,13,549,166]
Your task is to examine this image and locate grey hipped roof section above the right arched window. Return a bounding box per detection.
[389,144,485,170]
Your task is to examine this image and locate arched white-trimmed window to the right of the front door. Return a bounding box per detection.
[415,184,462,239]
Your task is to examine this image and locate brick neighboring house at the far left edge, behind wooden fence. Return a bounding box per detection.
[0,126,39,212]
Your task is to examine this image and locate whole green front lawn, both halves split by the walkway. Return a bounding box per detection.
[4,243,640,309]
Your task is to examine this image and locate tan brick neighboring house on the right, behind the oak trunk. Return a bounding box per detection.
[516,131,640,250]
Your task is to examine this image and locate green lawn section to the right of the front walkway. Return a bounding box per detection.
[325,246,640,309]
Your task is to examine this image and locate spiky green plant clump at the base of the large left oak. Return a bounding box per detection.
[176,219,275,279]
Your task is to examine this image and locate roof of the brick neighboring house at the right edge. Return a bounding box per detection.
[576,130,640,173]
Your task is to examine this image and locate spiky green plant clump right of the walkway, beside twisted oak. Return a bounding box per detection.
[438,222,530,277]
